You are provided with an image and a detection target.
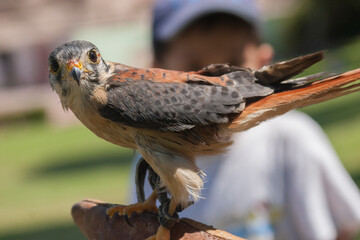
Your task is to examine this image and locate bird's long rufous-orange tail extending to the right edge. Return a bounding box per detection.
[229,68,360,132]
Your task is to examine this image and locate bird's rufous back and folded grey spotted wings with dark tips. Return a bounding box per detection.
[99,52,323,131]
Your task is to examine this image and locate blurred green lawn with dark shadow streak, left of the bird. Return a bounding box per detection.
[0,123,132,239]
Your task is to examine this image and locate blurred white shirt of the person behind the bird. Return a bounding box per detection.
[132,111,360,240]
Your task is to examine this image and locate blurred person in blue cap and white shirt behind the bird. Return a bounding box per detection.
[132,0,360,239]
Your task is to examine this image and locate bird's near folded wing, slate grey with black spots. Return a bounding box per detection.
[99,78,244,131]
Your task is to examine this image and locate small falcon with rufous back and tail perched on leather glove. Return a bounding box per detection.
[48,40,360,240]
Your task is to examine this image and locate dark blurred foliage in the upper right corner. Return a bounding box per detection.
[265,0,360,58]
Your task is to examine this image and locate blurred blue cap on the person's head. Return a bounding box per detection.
[153,0,261,41]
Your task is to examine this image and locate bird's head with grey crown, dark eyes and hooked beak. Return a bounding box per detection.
[48,41,109,108]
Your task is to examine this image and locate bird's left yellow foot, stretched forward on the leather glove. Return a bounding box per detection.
[106,191,158,218]
